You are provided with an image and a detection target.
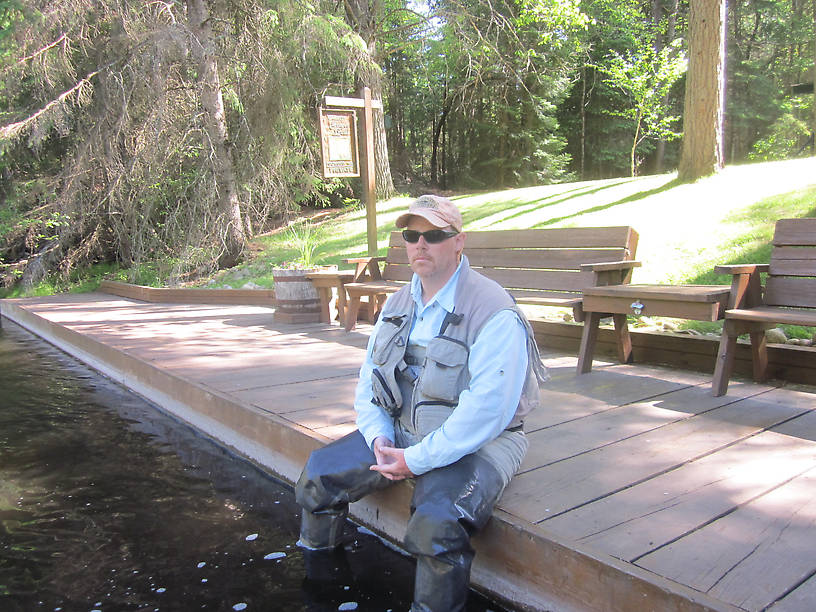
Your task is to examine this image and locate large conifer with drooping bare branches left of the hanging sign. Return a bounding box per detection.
[0,0,376,284]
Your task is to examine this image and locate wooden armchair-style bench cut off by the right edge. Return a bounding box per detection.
[712,218,816,396]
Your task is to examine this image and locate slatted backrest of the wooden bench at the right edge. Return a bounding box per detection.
[764,218,816,308]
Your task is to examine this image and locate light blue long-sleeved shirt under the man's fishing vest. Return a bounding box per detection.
[354,256,527,476]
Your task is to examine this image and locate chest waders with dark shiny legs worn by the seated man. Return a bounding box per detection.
[296,320,527,612]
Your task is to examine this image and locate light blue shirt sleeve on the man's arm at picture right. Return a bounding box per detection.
[405,310,528,476]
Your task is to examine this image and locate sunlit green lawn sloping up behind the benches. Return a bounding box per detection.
[4,157,816,337]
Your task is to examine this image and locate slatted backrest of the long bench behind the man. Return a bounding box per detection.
[383,227,638,302]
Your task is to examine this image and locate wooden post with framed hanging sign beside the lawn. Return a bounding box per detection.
[320,87,382,257]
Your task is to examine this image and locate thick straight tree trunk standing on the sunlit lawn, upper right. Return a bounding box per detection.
[678,0,725,181]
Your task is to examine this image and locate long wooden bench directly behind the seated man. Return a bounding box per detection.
[345,227,640,330]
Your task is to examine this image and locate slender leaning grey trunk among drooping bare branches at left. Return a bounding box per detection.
[187,0,247,267]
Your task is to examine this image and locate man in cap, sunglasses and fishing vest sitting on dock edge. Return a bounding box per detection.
[296,195,547,612]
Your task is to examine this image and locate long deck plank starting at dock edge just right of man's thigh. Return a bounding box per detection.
[501,400,802,522]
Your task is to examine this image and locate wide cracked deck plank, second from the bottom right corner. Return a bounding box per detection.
[637,469,816,610]
